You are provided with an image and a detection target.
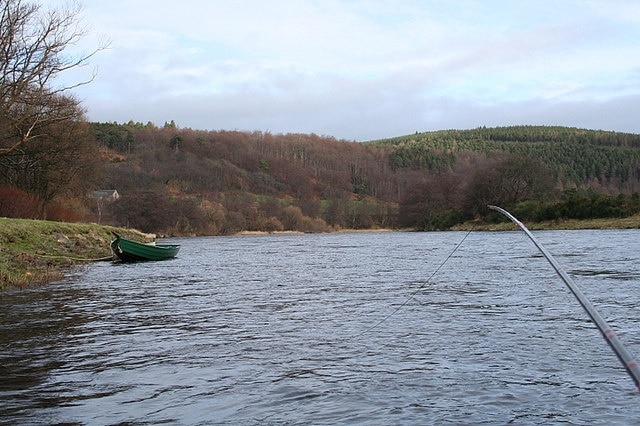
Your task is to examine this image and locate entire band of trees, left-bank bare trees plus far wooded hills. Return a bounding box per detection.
[0,0,640,235]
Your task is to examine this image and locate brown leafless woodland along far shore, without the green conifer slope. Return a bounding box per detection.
[92,123,554,234]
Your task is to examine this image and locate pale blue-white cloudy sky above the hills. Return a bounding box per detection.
[55,0,640,141]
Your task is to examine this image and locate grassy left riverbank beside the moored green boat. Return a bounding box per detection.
[0,218,151,290]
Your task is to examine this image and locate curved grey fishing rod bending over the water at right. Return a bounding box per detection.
[488,206,640,390]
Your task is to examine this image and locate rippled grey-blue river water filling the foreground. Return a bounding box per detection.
[0,230,640,425]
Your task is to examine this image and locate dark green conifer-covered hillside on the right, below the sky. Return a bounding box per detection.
[375,126,640,193]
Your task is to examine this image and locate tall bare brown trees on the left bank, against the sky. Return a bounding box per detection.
[0,0,101,216]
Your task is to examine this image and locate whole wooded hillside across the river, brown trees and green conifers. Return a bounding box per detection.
[81,122,640,234]
